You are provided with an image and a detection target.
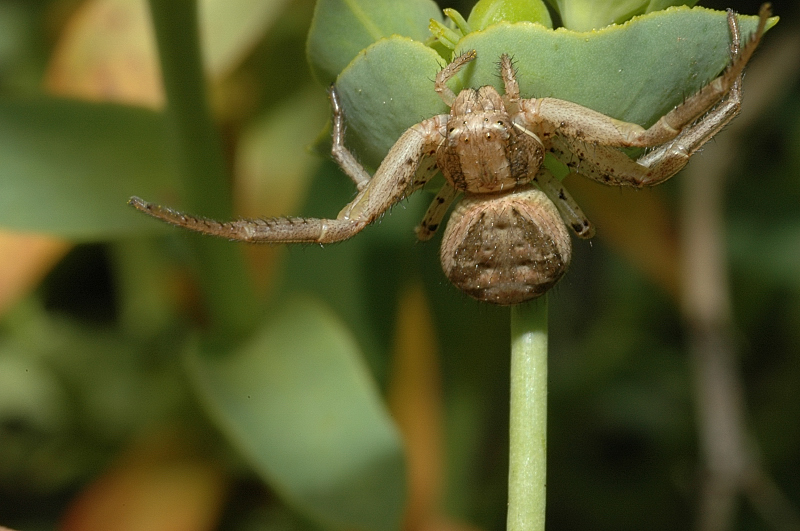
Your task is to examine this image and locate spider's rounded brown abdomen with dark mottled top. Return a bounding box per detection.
[441,188,572,305]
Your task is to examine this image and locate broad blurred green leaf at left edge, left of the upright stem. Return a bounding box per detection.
[0,99,178,240]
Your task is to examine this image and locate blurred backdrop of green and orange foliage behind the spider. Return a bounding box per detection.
[0,0,800,531]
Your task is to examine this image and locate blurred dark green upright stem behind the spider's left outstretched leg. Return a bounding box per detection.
[150,0,258,337]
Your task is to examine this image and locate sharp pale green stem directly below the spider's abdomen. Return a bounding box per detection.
[507,298,547,531]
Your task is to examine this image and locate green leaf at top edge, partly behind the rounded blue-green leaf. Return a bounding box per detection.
[306,0,442,85]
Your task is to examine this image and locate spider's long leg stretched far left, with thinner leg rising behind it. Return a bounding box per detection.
[128,89,447,243]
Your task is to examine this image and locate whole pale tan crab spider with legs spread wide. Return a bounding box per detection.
[130,4,770,305]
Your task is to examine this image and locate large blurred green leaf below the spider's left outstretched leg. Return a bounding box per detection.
[188,299,405,530]
